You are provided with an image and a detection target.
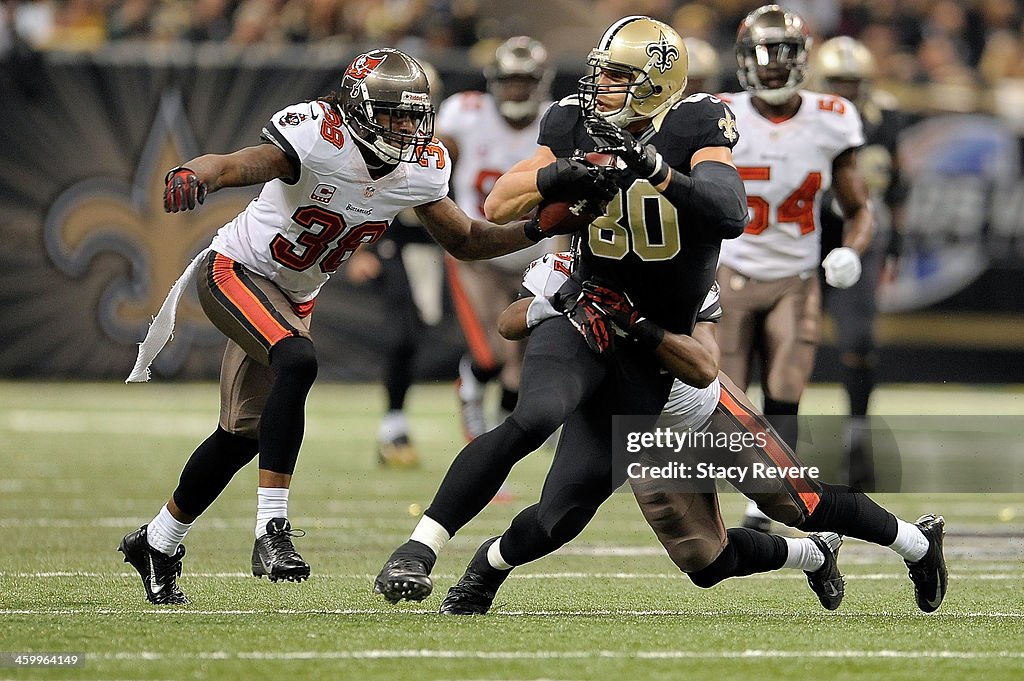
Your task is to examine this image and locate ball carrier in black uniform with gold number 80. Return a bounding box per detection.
[374,16,746,614]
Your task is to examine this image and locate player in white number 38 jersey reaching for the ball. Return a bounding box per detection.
[120,49,586,604]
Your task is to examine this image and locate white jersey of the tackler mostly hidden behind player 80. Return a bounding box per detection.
[522,251,722,430]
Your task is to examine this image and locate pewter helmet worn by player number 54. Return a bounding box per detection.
[736,5,811,105]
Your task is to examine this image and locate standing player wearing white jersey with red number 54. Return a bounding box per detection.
[718,5,872,529]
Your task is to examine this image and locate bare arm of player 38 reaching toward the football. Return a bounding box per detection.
[416,197,537,260]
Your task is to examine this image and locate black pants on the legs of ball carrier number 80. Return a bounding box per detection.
[427,317,672,565]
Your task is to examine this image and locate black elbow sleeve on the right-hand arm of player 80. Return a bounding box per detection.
[662,161,746,239]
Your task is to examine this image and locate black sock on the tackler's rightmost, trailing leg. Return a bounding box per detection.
[797,482,897,546]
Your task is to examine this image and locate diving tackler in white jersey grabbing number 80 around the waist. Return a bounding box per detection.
[491,253,946,611]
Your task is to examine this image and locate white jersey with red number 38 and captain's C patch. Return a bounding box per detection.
[211,101,451,303]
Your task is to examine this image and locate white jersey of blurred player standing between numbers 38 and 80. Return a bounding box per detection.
[434,90,551,272]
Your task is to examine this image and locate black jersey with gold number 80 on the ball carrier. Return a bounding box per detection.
[538,93,739,334]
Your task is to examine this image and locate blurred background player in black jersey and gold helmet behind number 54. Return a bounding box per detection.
[815,36,907,491]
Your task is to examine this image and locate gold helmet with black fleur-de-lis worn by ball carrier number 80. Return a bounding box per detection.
[579,16,687,128]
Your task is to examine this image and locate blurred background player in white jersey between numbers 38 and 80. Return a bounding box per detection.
[435,36,552,441]
